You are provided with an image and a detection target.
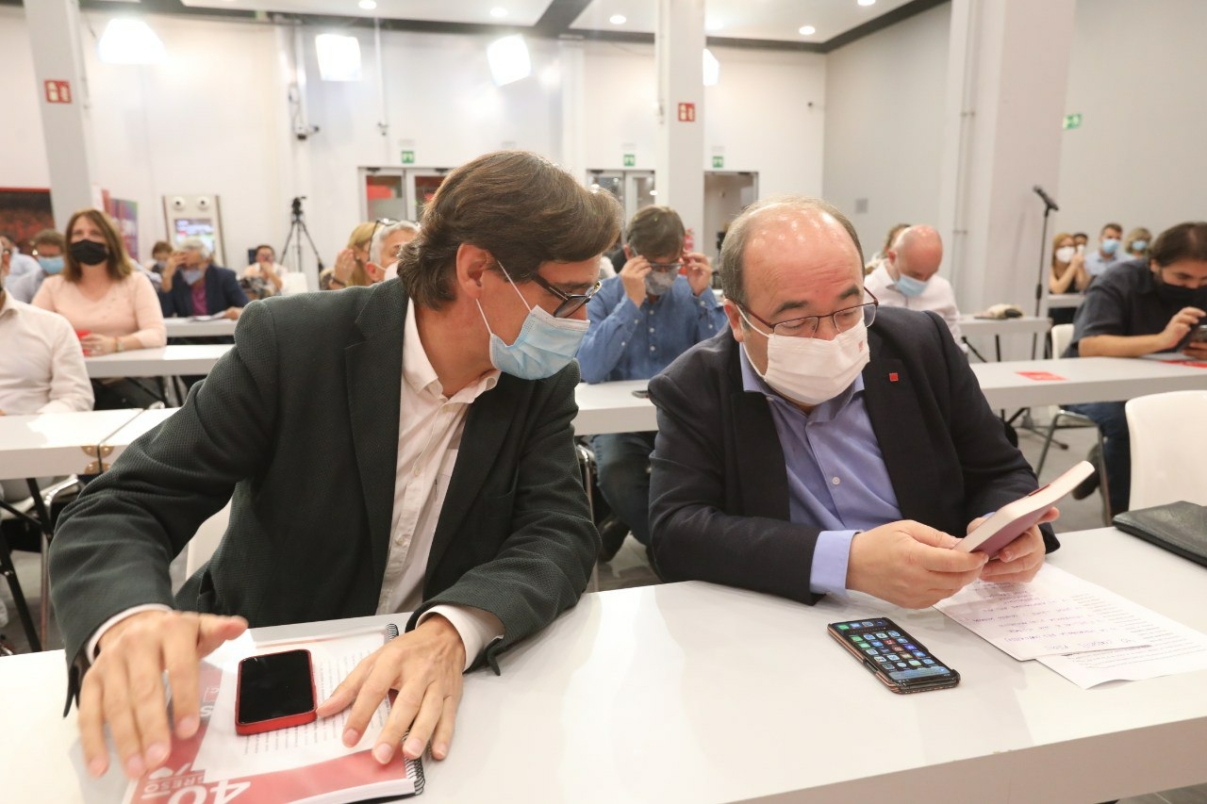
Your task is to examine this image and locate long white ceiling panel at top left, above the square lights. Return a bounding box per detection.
[180,0,552,25]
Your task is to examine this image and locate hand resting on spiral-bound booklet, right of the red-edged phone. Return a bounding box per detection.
[319,614,465,764]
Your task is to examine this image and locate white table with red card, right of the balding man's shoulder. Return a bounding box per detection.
[972,357,1207,409]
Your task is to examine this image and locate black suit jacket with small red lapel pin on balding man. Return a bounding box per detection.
[649,308,1059,602]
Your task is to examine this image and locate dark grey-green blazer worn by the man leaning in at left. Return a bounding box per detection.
[51,280,599,700]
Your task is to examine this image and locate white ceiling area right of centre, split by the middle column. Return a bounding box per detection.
[571,0,910,43]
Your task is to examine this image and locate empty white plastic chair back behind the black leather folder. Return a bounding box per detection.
[1125,391,1207,511]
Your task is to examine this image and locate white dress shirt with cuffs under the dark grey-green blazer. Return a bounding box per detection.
[87,304,503,670]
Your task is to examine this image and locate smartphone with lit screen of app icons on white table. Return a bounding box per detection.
[827,617,960,694]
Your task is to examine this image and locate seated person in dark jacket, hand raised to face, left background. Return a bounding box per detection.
[159,238,247,320]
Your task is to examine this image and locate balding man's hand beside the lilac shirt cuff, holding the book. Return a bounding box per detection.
[846,522,989,608]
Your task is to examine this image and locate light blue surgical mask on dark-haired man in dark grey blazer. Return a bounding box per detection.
[478,263,588,380]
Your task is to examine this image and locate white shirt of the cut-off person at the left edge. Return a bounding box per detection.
[0,293,93,415]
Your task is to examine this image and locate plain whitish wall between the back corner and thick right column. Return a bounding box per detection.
[823,4,951,256]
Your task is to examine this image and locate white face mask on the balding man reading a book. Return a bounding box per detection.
[739,308,870,407]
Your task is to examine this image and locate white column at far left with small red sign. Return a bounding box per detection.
[25,0,95,229]
